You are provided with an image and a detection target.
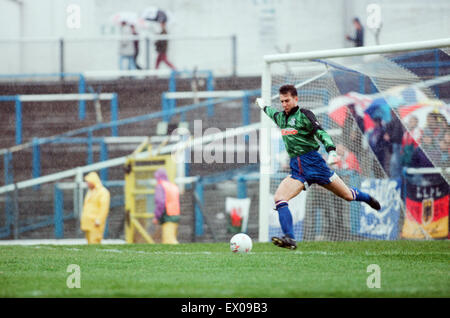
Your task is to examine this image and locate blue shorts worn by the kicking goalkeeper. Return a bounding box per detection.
[290,151,334,189]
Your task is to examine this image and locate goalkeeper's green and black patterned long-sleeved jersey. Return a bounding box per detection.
[264,106,336,158]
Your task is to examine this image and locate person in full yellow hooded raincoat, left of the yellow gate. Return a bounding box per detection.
[81,172,110,244]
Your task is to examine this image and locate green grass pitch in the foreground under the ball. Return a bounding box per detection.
[0,240,450,298]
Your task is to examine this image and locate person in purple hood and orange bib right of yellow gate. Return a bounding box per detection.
[153,168,180,244]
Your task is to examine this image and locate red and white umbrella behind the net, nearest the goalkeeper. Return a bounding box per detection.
[328,92,372,127]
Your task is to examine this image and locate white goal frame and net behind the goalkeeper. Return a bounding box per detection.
[259,39,450,242]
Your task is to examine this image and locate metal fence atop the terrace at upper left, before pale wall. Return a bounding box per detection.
[0,35,237,76]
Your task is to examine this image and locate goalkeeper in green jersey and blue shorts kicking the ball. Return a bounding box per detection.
[256,85,381,249]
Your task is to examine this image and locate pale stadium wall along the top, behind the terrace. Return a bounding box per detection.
[0,0,450,75]
